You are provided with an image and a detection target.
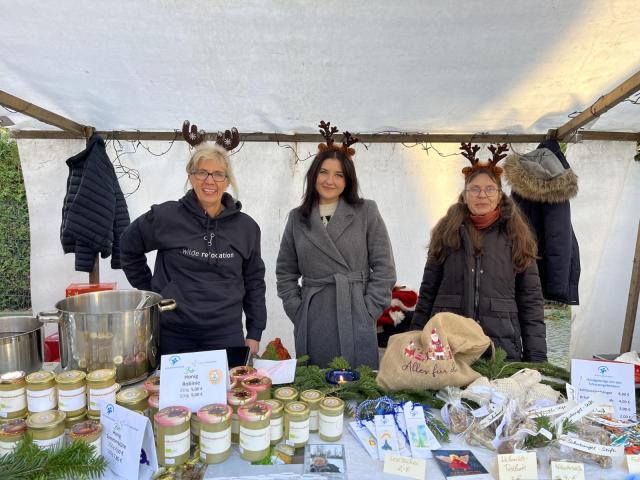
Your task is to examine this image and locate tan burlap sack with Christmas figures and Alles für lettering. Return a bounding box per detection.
[376,312,491,391]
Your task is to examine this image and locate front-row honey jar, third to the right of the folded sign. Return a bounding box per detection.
[238,402,271,462]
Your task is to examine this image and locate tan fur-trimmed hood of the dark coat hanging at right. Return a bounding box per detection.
[503,140,578,203]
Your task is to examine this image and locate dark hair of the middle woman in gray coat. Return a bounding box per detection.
[298,150,362,225]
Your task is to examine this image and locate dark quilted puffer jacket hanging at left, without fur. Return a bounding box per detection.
[60,135,129,272]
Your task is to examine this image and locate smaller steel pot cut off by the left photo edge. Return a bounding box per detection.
[0,316,44,373]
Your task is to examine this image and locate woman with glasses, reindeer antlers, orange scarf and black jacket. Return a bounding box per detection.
[412,144,547,362]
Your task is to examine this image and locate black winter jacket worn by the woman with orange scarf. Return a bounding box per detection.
[411,210,547,362]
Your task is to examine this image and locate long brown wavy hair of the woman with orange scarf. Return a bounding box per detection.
[429,169,538,272]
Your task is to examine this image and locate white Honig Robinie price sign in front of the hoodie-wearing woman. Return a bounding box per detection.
[159,350,229,412]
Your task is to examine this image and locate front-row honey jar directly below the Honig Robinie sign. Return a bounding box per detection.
[197,403,231,464]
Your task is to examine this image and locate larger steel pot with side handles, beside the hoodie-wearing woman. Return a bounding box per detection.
[37,290,176,385]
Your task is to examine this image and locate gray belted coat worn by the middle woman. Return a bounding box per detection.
[276,198,396,368]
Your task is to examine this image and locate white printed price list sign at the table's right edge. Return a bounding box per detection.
[571,359,636,419]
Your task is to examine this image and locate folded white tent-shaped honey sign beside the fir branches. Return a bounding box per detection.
[99,400,158,480]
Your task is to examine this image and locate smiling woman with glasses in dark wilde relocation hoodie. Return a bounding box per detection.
[121,144,267,355]
